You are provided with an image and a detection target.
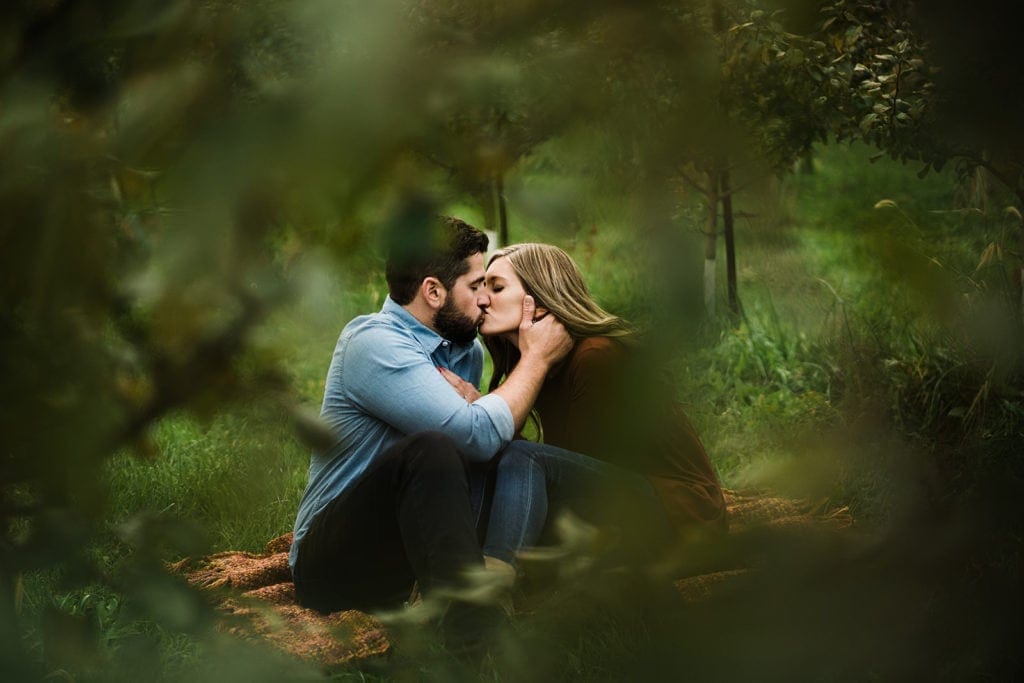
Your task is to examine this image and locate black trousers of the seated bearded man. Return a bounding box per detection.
[294,432,483,612]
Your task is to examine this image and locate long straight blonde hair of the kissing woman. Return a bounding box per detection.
[484,242,633,389]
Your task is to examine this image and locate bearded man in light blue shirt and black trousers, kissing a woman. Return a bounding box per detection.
[290,218,571,612]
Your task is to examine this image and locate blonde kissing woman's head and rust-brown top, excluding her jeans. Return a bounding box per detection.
[480,244,727,548]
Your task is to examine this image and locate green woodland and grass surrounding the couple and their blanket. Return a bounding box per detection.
[0,0,1024,680]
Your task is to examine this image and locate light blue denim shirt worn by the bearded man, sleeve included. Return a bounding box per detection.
[291,297,514,567]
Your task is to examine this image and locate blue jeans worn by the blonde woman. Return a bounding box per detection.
[483,440,674,563]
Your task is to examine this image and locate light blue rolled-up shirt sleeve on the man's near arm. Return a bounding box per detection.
[341,326,513,461]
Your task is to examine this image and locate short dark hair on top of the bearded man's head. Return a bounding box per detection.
[384,216,487,305]
